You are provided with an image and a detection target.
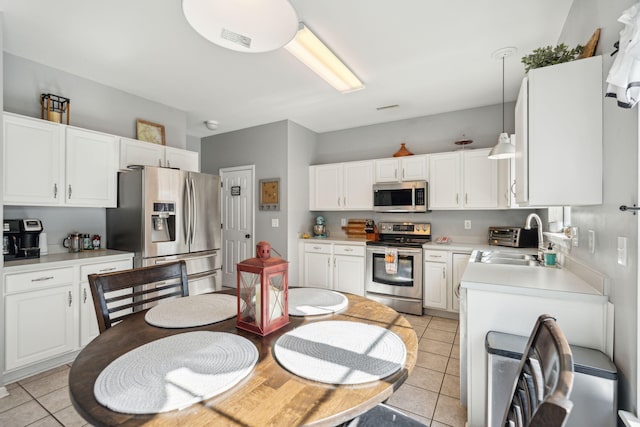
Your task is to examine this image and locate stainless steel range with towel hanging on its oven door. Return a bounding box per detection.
[365,222,431,315]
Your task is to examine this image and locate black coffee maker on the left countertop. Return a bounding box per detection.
[2,219,42,261]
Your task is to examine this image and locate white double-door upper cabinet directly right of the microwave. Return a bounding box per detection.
[429,148,498,209]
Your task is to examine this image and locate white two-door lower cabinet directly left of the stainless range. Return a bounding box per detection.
[300,242,365,296]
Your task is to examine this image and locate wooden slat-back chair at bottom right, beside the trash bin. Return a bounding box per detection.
[502,314,573,427]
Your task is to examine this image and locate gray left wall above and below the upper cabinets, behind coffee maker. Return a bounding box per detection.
[2,53,192,252]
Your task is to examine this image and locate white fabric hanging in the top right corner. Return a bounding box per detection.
[605,3,640,108]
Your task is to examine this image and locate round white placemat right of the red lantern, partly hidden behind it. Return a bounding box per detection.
[289,288,349,316]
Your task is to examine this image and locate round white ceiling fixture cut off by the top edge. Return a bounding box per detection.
[182,0,298,53]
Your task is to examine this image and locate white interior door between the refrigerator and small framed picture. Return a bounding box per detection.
[220,165,255,288]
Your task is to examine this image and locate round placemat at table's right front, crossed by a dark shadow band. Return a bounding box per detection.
[274,320,407,384]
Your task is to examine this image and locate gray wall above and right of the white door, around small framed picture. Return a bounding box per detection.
[201,120,289,259]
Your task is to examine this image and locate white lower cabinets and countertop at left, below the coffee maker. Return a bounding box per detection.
[2,254,133,379]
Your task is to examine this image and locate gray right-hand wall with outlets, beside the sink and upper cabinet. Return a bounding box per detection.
[559,0,638,413]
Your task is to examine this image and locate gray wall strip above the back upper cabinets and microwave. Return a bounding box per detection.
[313,102,515,164]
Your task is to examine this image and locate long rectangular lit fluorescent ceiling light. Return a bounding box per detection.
[285,23,364,93]
